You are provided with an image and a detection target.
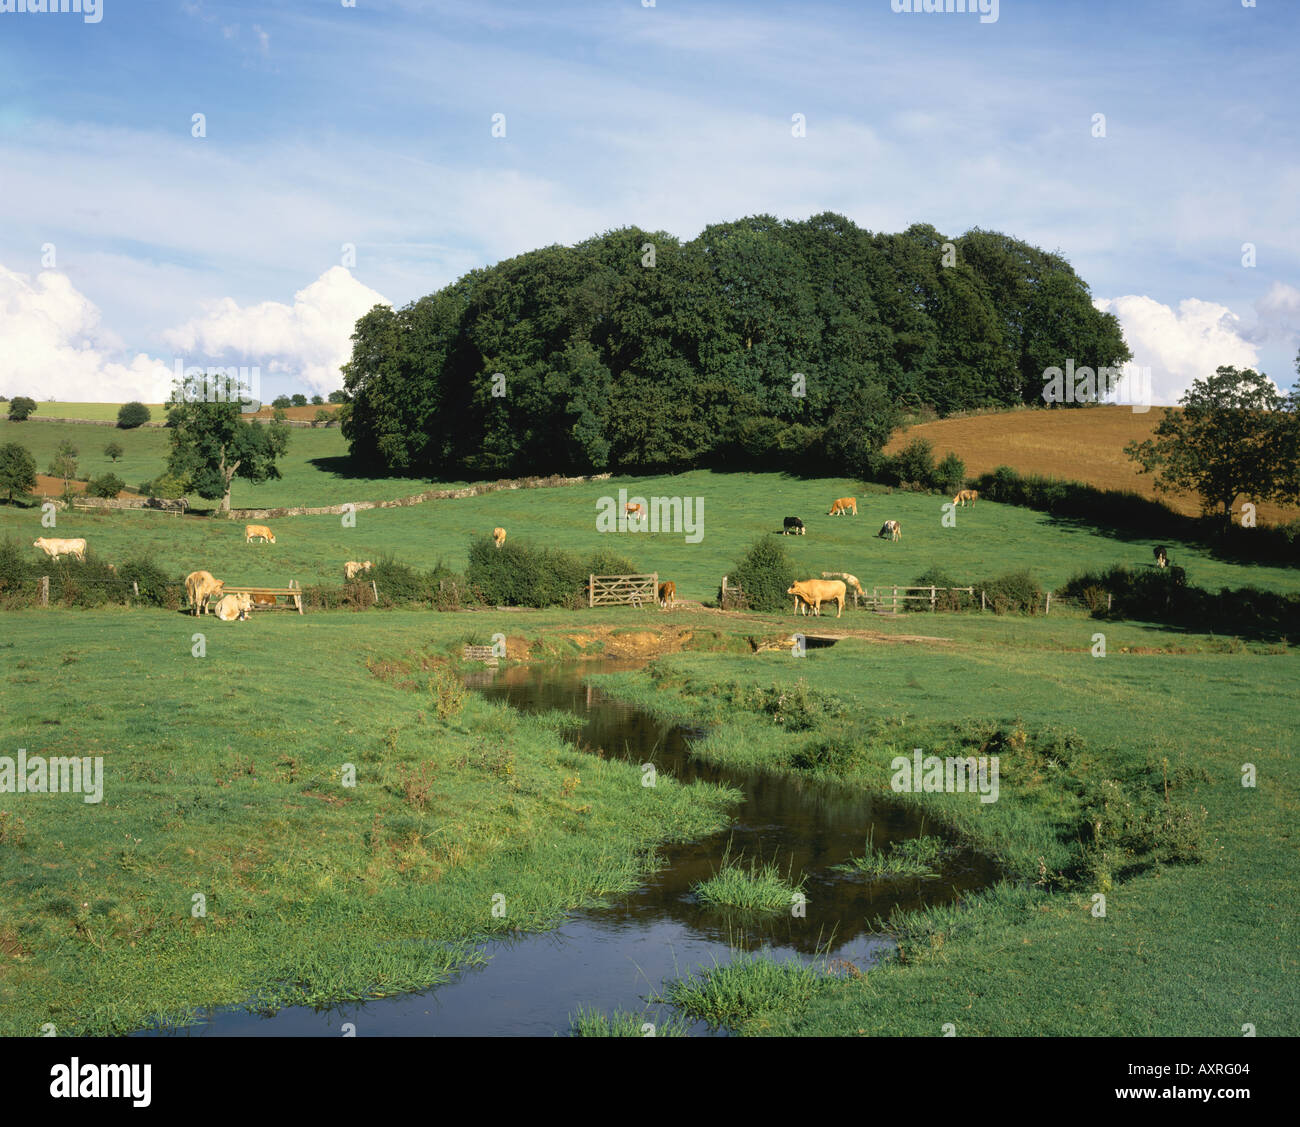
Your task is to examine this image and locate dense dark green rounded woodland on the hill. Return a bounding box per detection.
[342,213,1131,477]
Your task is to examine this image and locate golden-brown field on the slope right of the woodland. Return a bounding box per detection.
[885,407,1300,523]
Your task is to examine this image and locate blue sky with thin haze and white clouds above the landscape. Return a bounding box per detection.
[0,0,1300,403]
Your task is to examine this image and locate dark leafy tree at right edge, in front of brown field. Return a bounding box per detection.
[1125,365,1300,524]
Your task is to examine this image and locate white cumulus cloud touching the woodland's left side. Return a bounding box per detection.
[163,266,390,393]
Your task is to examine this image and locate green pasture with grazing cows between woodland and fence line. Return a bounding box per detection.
[0,462,1296,601]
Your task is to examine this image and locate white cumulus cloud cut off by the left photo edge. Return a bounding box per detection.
[0,265,166,403]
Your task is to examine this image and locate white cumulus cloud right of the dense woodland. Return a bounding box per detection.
[1093,294,1258,404]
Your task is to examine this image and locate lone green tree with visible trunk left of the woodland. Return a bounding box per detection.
[168,390,289,512]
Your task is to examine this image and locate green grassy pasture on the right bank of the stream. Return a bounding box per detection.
[599,629,1300,1037]
